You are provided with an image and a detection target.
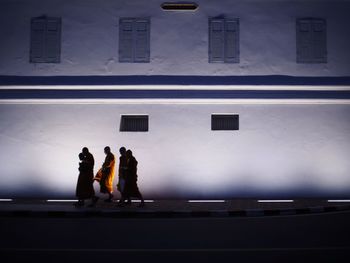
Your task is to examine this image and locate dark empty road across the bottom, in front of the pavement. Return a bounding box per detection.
[0,201,350,262]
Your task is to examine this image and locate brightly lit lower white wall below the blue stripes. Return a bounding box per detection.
[0,101,350,198]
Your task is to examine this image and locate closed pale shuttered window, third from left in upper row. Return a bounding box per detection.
[209,18,239,63]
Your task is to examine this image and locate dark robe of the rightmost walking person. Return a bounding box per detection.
[124,156,141,198]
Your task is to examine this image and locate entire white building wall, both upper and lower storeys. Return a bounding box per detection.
[0,0,350,198]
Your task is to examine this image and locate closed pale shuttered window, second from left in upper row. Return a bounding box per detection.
[119,18,150,63]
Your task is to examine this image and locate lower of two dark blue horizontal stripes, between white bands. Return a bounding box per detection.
[0,89,350,100]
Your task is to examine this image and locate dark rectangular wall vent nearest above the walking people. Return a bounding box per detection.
[119,115,148,132]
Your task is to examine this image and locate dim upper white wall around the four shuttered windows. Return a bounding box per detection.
[0,0,350,76]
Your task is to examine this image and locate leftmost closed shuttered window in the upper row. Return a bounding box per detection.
[30,17,61,63]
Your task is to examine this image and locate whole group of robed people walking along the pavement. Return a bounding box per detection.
[75,146,145,207]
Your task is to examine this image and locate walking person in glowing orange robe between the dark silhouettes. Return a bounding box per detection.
[94,146,115,202]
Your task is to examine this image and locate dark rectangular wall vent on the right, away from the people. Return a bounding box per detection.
[211,114,239,131]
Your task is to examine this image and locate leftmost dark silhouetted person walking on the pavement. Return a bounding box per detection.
[75,153,95,206]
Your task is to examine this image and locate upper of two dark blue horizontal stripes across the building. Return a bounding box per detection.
[0,75,350,86]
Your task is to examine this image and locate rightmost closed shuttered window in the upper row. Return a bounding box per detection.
[296,18,327,63]
